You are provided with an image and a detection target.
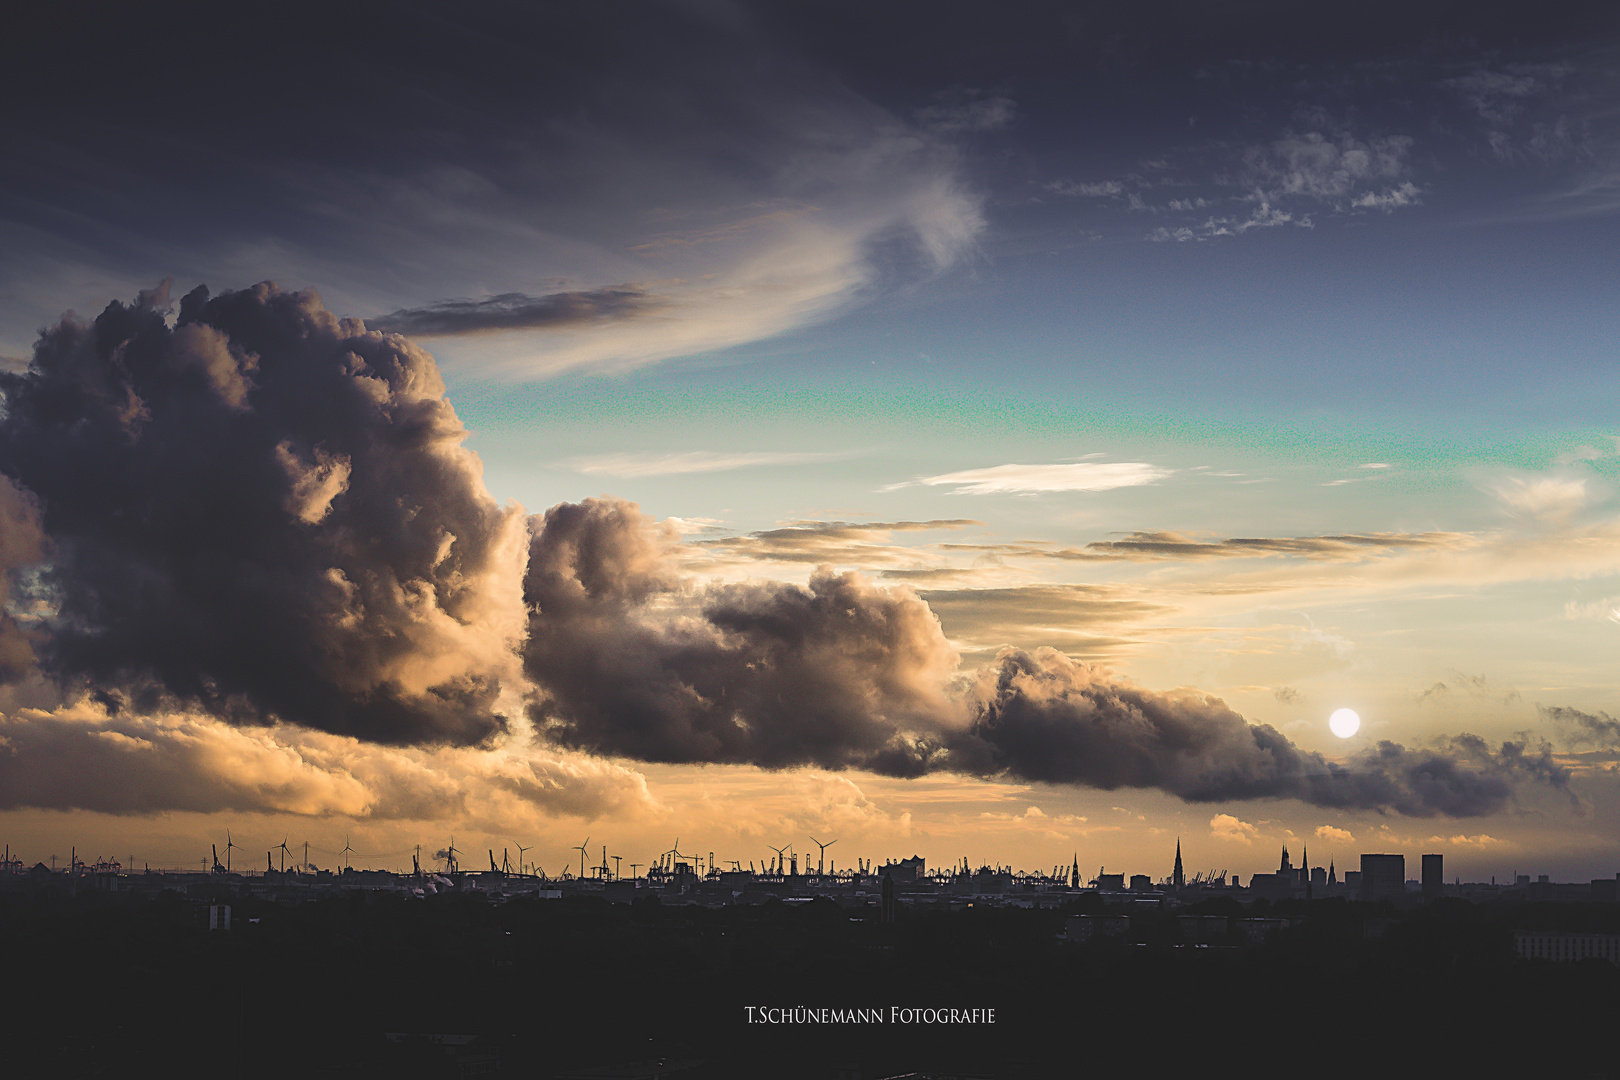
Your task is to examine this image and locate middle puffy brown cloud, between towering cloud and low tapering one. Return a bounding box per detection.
[523,500,956,774]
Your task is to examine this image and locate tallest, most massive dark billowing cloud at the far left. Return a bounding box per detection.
[0,285,523,743]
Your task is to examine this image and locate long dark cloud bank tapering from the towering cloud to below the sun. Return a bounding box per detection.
[525,500,1568,816]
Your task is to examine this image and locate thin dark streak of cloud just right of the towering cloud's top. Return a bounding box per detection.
[368,285,664,337]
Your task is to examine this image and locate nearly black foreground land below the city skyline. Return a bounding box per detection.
[0,892,1620,1080]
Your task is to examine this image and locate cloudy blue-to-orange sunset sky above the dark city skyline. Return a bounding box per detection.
[0,0,1620,881]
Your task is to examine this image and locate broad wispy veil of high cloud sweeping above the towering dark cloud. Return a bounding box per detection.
[0,3,991,379]
